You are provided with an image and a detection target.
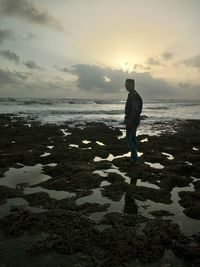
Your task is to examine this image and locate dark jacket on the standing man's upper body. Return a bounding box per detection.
[125,90,143,123]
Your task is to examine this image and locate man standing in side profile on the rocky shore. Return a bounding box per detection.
[125,79,143,163]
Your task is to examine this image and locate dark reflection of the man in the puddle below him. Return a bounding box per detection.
[124,179,138,214]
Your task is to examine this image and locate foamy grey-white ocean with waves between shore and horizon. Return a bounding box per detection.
[0,98,200,135]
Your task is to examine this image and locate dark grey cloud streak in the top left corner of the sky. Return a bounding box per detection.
[1,0,63,31]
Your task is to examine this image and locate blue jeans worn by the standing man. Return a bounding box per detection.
[126,120,140,161]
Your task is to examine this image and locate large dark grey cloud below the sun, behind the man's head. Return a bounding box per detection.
[68,64,176,99]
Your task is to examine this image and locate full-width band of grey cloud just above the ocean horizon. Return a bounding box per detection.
[0,64,200,101]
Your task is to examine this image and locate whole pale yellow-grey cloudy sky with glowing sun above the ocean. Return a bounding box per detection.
[0,0,200,100]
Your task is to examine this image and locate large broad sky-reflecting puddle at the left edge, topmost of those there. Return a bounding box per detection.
[0,164,52,188]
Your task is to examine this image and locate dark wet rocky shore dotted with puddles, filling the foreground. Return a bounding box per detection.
[0,114,200,267]
